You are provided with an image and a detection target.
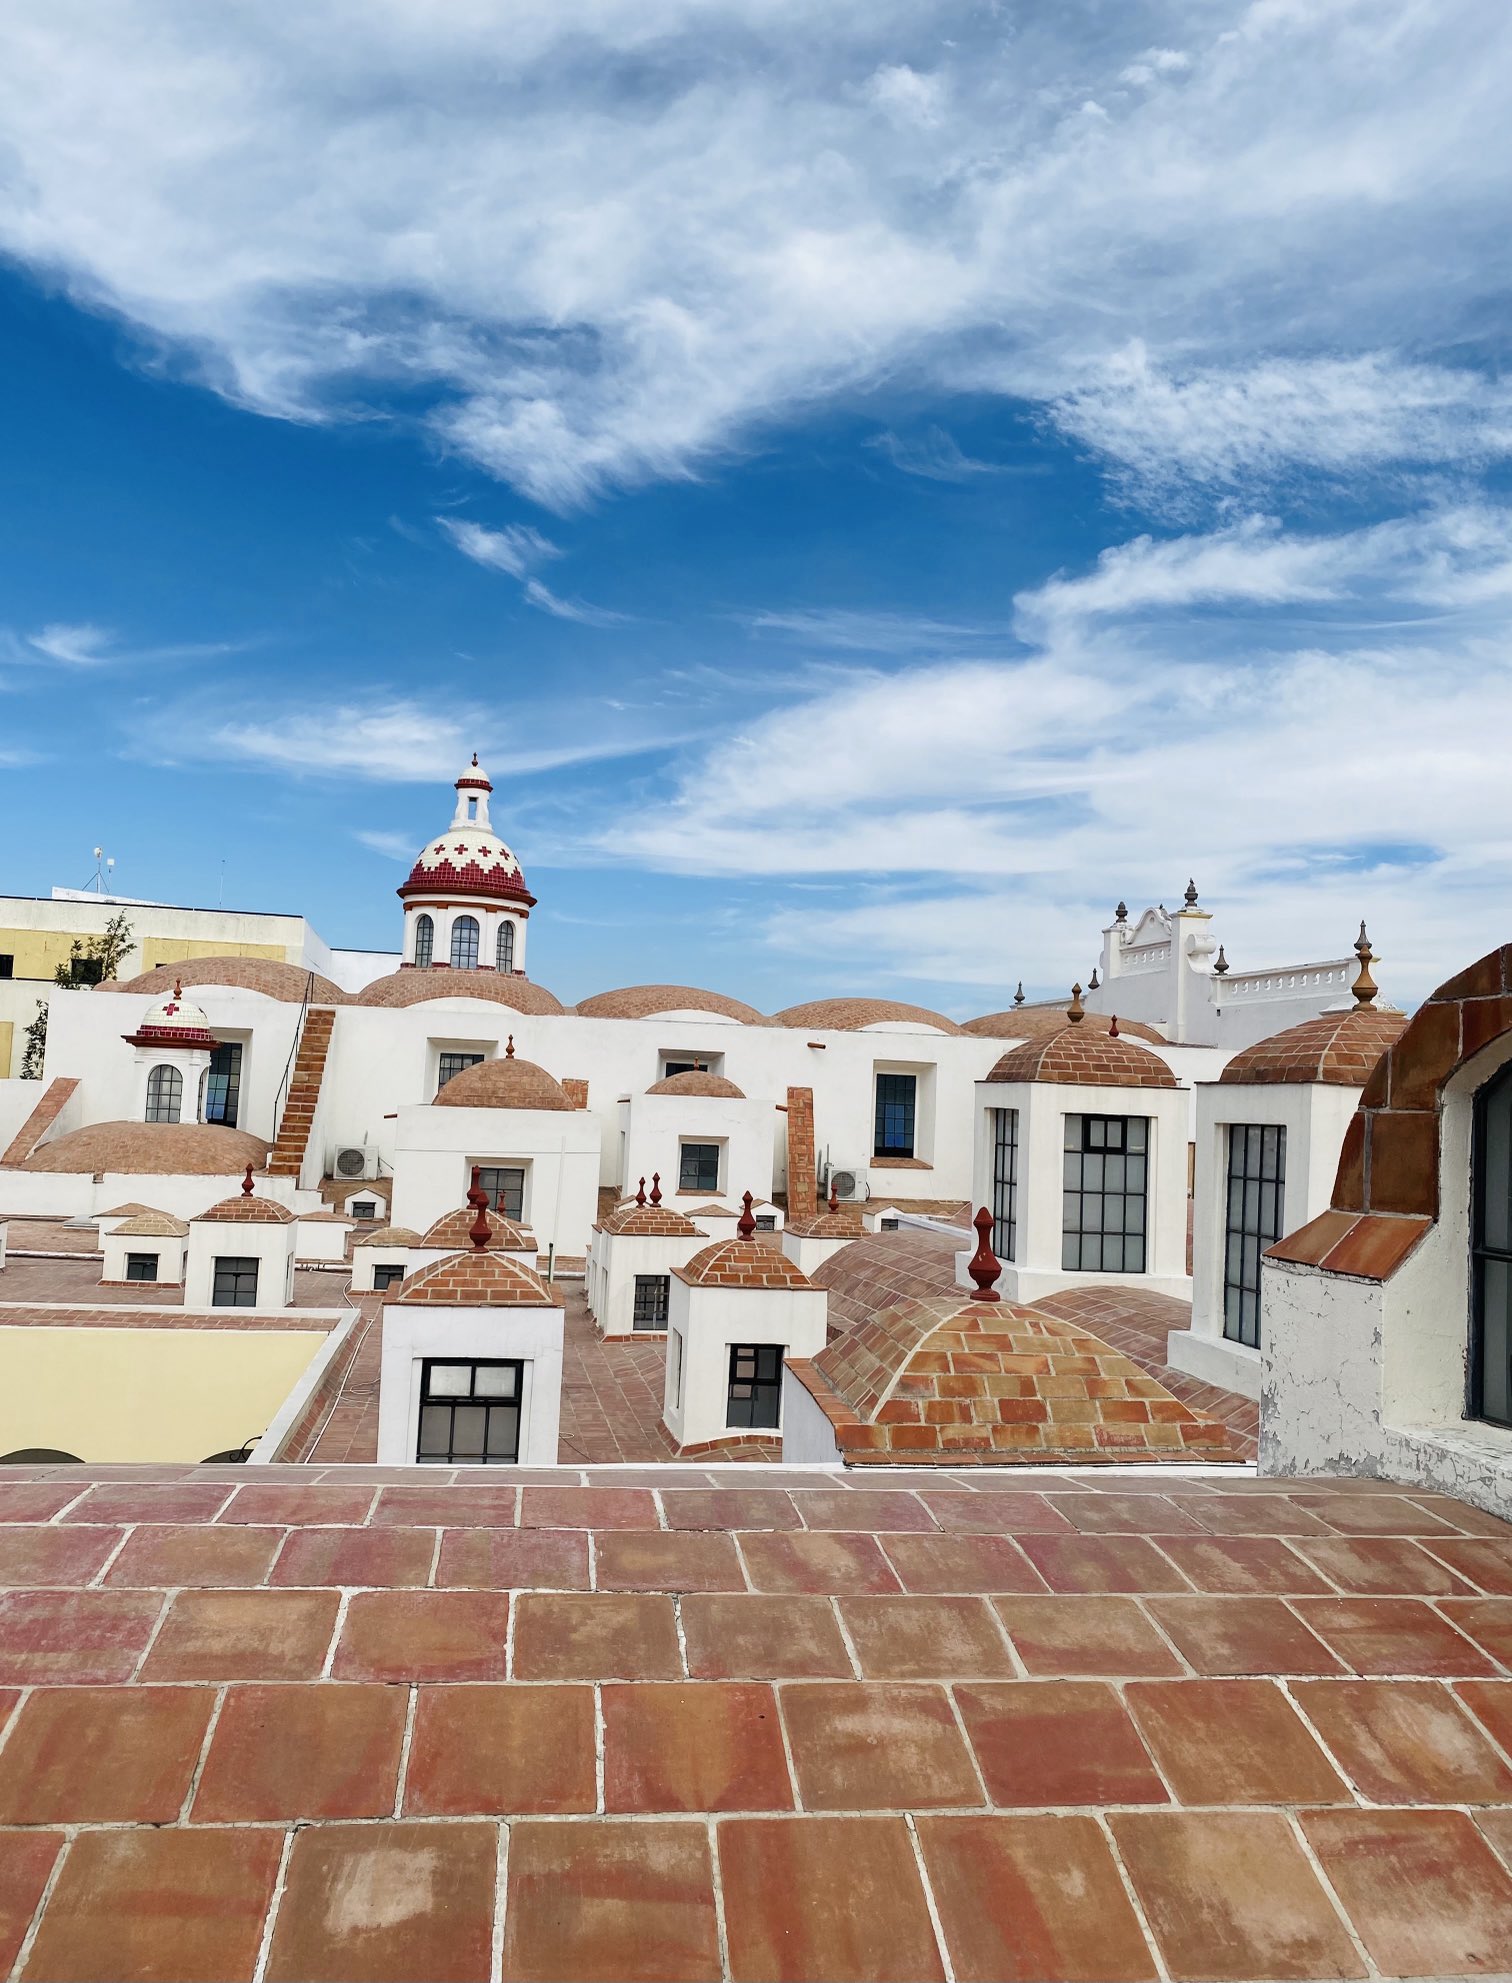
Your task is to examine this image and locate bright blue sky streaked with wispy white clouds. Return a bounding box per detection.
[0,0,1512,1015]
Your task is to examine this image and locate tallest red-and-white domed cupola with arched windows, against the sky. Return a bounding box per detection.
[399,752,536,976]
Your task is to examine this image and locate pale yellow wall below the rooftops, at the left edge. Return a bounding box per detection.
[0,1329,325,1463]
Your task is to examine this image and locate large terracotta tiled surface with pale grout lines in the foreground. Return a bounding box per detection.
[0,1465,1512,1983]
